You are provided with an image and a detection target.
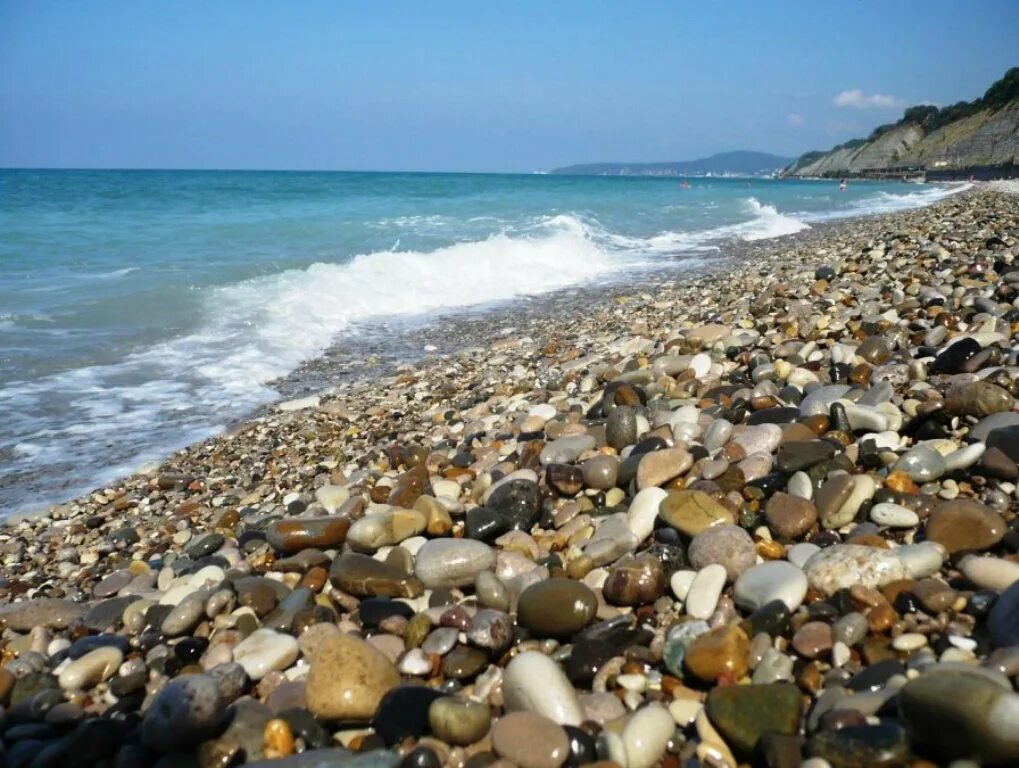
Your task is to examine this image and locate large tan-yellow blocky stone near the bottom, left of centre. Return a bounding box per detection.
[305,635,399,721]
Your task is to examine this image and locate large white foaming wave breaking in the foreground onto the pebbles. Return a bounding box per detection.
[0,216,621,508]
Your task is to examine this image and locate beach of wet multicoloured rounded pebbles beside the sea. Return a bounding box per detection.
[0,186,1019,768]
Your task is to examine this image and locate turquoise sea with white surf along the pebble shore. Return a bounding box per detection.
[0,170,964,516]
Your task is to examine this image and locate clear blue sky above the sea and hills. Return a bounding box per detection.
[0,0,1019,171]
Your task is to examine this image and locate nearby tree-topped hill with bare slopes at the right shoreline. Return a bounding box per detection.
[784,67,1019,178]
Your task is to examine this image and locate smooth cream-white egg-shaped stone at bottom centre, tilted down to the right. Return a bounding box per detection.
[502,651,585,725]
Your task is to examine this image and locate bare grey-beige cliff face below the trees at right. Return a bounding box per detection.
[786,99,1019,176]
